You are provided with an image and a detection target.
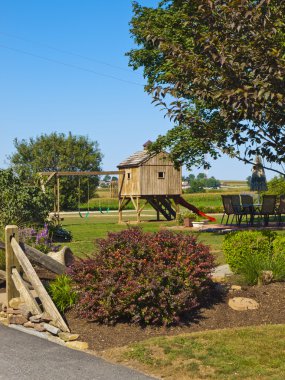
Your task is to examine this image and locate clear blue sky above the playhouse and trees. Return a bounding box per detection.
[0,0,280,179]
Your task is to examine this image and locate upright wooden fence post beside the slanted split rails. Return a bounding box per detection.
[5,225,20,306]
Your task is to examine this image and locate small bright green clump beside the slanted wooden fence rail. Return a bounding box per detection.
[48,274,77,313]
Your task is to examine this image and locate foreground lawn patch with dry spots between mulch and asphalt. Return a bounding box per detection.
[103,325,285,380]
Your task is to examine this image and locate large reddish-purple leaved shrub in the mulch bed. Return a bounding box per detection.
[69,228,214,325]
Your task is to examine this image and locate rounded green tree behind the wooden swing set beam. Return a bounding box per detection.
[10,132,102,209]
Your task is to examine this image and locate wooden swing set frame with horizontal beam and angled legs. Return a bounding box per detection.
[38,170,122,216]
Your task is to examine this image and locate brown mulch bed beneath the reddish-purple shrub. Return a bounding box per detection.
[63,283,285,351]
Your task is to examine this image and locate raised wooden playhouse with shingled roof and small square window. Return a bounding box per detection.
[118,142,182,222]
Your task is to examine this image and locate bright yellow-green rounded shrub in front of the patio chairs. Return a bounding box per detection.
[223,231,285,284]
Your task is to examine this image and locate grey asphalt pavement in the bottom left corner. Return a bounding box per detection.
[0,325,153,380]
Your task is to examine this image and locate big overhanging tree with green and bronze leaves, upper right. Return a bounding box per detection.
[128,0,285,174]
